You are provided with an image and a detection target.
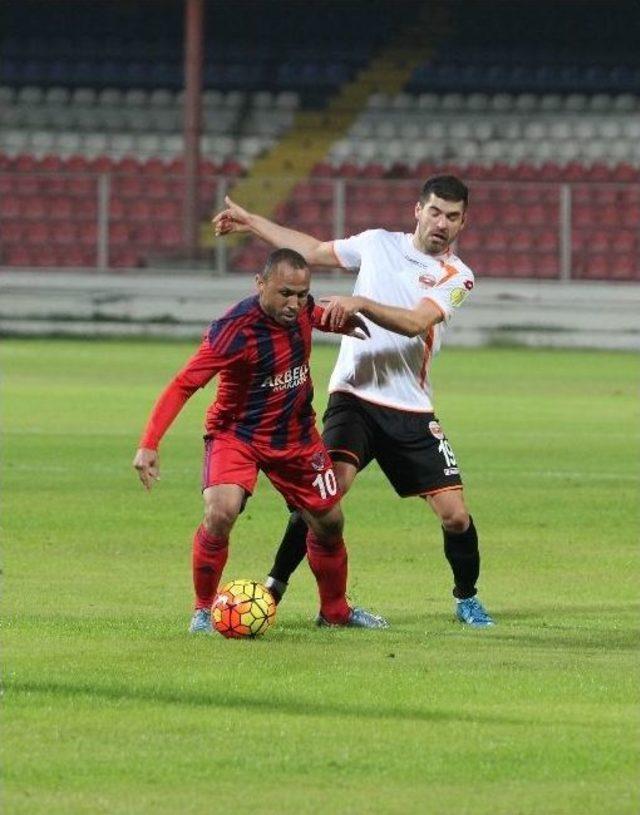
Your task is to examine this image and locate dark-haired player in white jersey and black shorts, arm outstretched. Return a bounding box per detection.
[213,175,493,628]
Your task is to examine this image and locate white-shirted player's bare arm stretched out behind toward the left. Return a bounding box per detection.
[211,196,338,266]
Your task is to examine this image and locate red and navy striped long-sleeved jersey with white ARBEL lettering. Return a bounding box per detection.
[140,295,326,450]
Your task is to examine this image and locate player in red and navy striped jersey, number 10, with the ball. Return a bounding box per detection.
[133,249,387,633]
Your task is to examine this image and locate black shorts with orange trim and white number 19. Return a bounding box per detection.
[322,393,462,498]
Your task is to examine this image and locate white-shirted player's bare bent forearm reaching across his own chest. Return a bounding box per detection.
[321,296,442,337]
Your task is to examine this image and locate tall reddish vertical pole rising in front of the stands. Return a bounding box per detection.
[183,0,204,258]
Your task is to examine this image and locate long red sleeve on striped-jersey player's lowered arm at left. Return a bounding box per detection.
[139,323,246,450]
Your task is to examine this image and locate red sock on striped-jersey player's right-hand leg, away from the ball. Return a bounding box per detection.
[307,530,350,623]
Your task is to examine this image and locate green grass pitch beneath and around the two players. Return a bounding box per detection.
[1,340,640,815]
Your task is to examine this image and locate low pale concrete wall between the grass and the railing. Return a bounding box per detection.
[0,271,640,350]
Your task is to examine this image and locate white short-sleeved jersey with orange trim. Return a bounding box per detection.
[329,229,473,413]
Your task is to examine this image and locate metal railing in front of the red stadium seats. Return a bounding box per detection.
[0,171,640,280]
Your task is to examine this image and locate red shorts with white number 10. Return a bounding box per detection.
[202,433,341,514]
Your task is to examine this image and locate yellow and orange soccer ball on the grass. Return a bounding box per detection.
[211,579,276,638]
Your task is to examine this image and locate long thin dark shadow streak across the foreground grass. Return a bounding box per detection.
[5,679,540,727]
